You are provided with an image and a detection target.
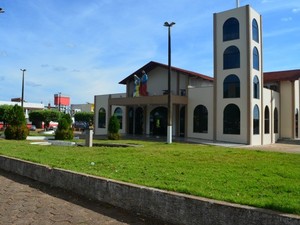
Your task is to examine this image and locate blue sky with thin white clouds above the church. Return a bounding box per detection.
[0,0,300,105]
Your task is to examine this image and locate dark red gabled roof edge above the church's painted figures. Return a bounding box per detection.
[119,61,214,84]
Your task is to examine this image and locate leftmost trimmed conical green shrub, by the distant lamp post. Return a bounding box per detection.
[4,105,29,140]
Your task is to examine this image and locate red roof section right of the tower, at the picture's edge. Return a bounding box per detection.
[264,70,300,82]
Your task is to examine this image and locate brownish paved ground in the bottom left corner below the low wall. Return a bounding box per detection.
[0,170,169,225]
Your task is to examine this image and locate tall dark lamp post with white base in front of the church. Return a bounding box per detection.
[164,22,175,144]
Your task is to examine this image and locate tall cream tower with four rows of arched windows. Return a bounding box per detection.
[214,5,263,145]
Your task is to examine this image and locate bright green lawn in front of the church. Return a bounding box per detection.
[0,140,300,214]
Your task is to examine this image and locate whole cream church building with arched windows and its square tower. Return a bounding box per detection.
[94,5,300,145]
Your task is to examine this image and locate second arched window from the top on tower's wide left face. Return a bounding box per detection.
[223,46,240,70]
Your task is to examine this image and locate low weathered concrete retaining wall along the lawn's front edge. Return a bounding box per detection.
[0,156,300,225]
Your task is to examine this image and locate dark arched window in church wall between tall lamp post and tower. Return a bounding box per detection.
[194,105,208,133]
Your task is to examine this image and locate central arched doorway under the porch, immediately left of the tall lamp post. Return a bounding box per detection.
[150,106,168,136]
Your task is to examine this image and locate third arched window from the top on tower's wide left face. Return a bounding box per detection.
[223,74,240,98]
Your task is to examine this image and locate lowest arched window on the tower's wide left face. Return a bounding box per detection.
[223,104,241,134]
